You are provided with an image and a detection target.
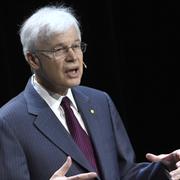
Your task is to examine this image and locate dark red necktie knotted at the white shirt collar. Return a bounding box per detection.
[61,97,97,170]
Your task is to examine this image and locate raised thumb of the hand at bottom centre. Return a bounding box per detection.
[53,156,72,177]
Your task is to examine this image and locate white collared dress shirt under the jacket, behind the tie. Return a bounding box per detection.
[31,74,87,133]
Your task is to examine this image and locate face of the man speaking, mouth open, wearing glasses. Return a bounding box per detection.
[35,27,83,94]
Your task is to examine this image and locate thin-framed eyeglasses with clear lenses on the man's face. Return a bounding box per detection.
[33,42,87,59]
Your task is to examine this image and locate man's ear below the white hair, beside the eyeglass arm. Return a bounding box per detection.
[26,52,39,70]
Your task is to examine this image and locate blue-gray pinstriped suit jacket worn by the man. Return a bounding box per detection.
[0,81,168,180]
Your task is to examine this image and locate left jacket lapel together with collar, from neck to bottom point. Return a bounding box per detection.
[24,82,93,171]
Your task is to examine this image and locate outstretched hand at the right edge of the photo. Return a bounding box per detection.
[146,149,180,180]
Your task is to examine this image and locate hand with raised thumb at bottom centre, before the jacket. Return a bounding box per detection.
[50,157,97,180]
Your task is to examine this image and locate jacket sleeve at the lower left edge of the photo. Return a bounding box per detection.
[0,118,30,180]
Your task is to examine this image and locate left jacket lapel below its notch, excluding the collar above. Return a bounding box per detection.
[34,107,92,171]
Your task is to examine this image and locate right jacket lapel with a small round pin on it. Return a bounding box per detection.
[73,88,107,174]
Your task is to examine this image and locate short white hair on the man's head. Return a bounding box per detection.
[19,5,81,56]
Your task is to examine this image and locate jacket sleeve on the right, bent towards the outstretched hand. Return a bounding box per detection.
[106,94,170,180]
